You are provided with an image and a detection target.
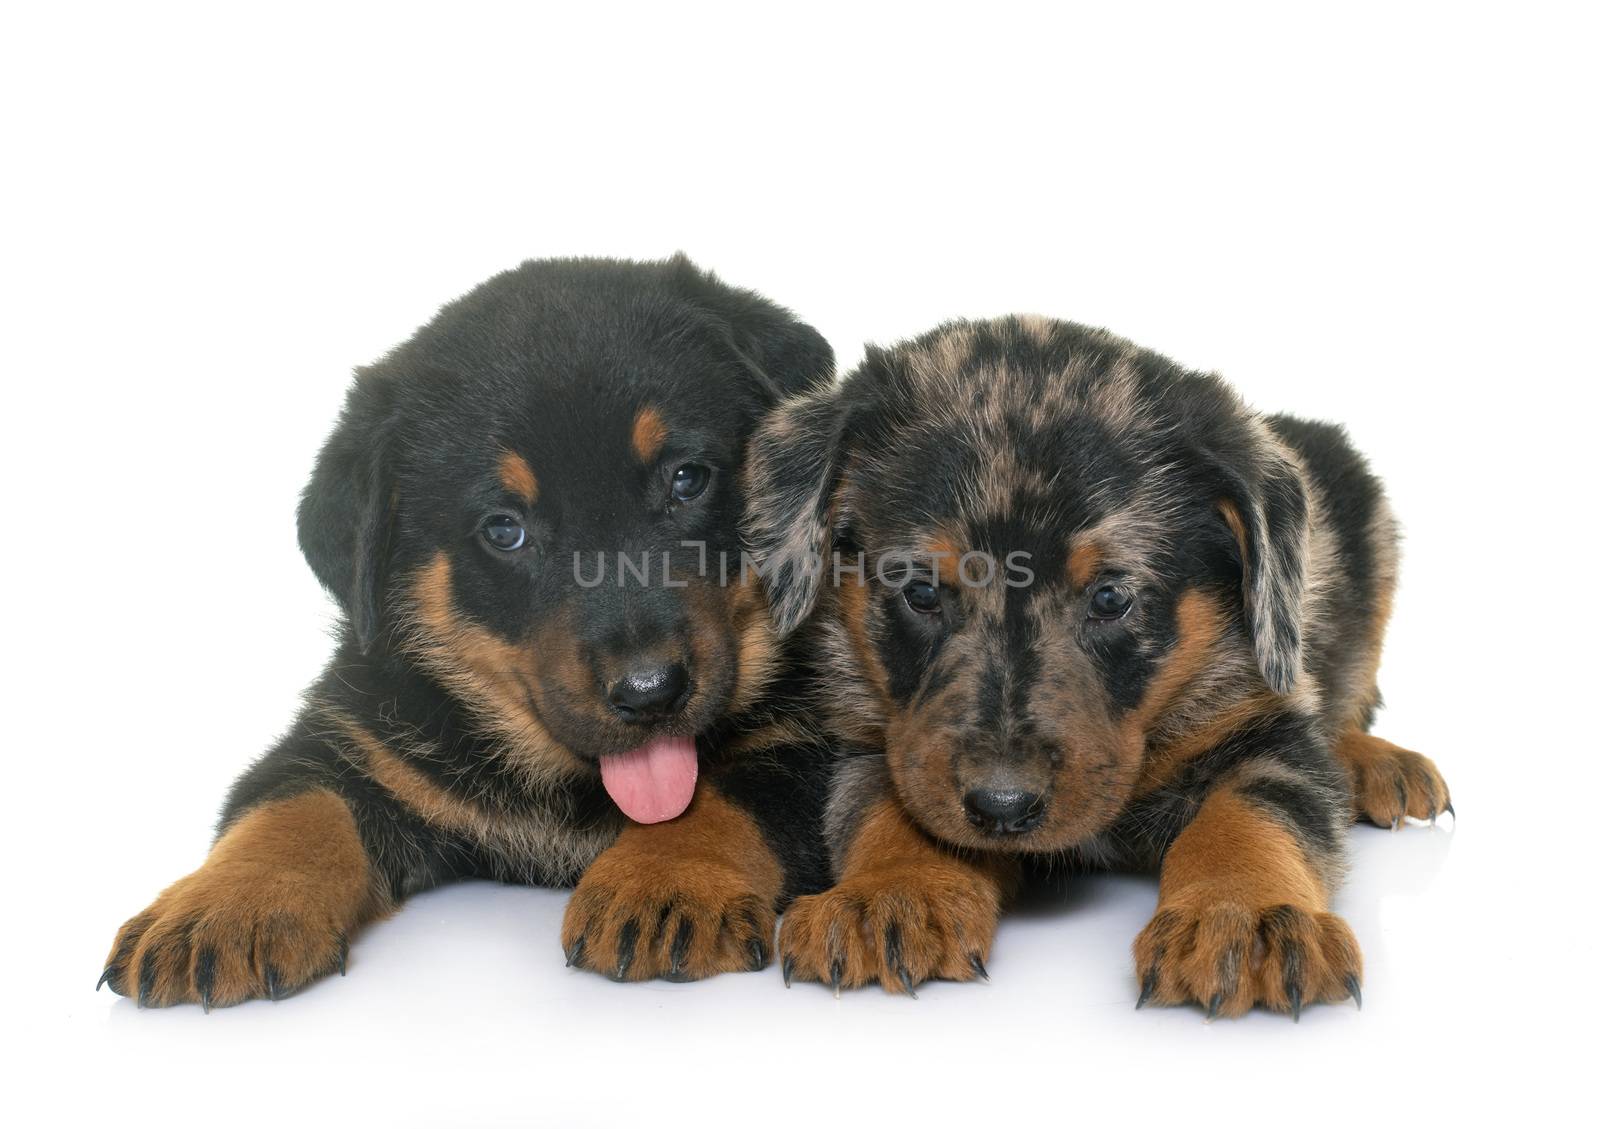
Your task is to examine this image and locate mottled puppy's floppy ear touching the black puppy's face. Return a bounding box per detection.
[744,387,850,636]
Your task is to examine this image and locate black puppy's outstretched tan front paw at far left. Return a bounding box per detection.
[96,868,350,1011]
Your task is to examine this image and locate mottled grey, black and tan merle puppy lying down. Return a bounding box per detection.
[749,318,1450,1015]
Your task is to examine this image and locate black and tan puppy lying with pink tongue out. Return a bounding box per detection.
[102,257,832,1007]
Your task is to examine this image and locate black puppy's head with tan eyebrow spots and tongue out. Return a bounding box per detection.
[299,257,832,820]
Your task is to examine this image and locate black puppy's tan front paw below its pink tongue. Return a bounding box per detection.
[562,848,776,980]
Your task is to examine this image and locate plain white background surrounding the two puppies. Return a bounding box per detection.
[0,3,1600,1126]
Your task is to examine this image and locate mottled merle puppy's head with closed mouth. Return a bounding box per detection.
[749,318,1307,851]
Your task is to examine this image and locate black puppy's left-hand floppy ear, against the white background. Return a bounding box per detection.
[299,371,394,651]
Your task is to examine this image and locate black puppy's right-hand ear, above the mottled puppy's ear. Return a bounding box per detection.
[667,251,834,403]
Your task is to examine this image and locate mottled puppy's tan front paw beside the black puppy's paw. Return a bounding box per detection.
[778,864,1000,996]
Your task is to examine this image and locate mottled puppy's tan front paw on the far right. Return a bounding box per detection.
[1133,902,1362,1020]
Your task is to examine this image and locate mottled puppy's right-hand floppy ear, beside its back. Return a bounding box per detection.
[1218,433,1310,694]
